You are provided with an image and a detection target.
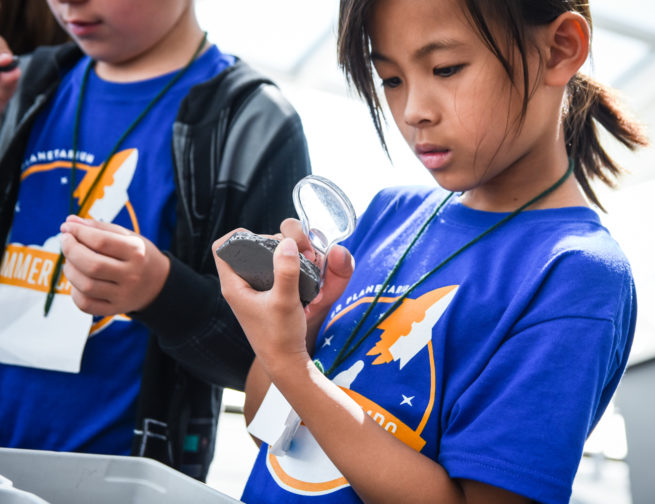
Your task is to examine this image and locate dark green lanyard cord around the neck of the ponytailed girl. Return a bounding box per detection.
[325,159,575,376]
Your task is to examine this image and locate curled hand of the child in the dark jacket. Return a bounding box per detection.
[61,216,170,315]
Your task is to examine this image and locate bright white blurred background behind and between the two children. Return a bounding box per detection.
[196,0,655,504]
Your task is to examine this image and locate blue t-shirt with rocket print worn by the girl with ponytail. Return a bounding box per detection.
[242,188,636,504]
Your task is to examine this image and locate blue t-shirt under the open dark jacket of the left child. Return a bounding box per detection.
[0,47,235,454]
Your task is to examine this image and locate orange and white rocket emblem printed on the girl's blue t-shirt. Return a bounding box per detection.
[266,285,459,495]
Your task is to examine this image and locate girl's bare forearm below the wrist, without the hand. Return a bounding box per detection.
[269,358,466,503]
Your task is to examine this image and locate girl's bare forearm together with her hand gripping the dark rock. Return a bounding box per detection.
[218,231,527,504]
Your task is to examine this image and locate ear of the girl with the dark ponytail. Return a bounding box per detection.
[544,12,591,86]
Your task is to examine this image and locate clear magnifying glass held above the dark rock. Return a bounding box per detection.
[292,175,357,283]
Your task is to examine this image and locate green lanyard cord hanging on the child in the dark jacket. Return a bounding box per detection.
[43,32,207,316]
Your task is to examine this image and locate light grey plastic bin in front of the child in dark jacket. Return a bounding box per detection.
[0,448,239,504]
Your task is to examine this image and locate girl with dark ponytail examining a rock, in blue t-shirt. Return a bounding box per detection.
[215,0,646,504]
